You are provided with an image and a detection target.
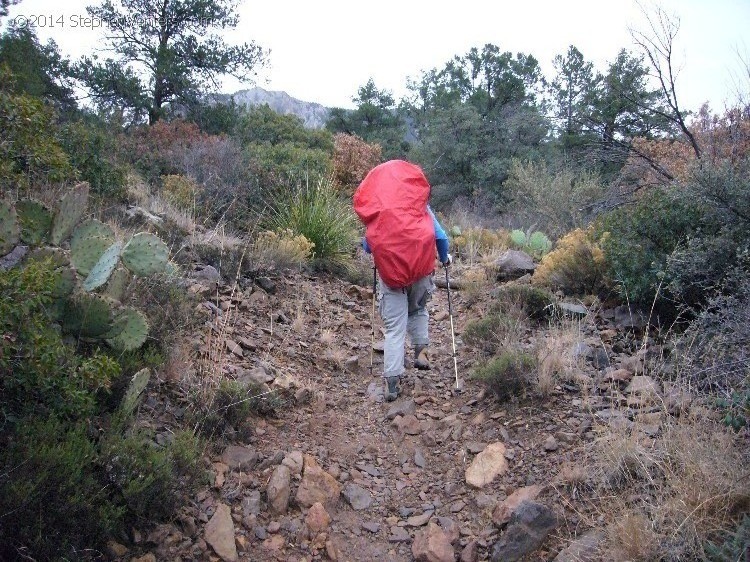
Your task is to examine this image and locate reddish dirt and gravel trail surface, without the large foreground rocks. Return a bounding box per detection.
[131,270,590,562]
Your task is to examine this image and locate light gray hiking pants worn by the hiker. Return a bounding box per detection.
[378,275,435,377]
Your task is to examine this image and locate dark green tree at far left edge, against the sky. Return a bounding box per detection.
[0,25,76,113]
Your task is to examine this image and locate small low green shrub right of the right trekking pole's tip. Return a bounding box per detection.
[471,350,536,402]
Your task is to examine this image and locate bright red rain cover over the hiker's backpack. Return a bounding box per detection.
[354,160,436,289]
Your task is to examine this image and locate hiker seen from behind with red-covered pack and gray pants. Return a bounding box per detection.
[354,160,452,401]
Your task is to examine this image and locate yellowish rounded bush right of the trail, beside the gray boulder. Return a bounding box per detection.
[532,228,606,295]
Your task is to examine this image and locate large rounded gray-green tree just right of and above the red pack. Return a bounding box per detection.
[407,45,547,207]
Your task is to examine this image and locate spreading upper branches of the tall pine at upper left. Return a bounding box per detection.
[78,0,266,124]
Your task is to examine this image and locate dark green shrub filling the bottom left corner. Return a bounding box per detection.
[0,417,125,560]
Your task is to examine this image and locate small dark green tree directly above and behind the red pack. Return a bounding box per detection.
[326,78,409,160]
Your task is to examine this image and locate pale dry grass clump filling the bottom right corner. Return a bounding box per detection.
[596,410,750,562]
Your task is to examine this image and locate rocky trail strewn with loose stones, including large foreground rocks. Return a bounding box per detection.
[112,266,676,562]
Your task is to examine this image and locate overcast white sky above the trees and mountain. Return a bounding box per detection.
[4,0,750,110]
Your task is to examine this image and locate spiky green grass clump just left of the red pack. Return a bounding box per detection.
[271,177,357,271]
